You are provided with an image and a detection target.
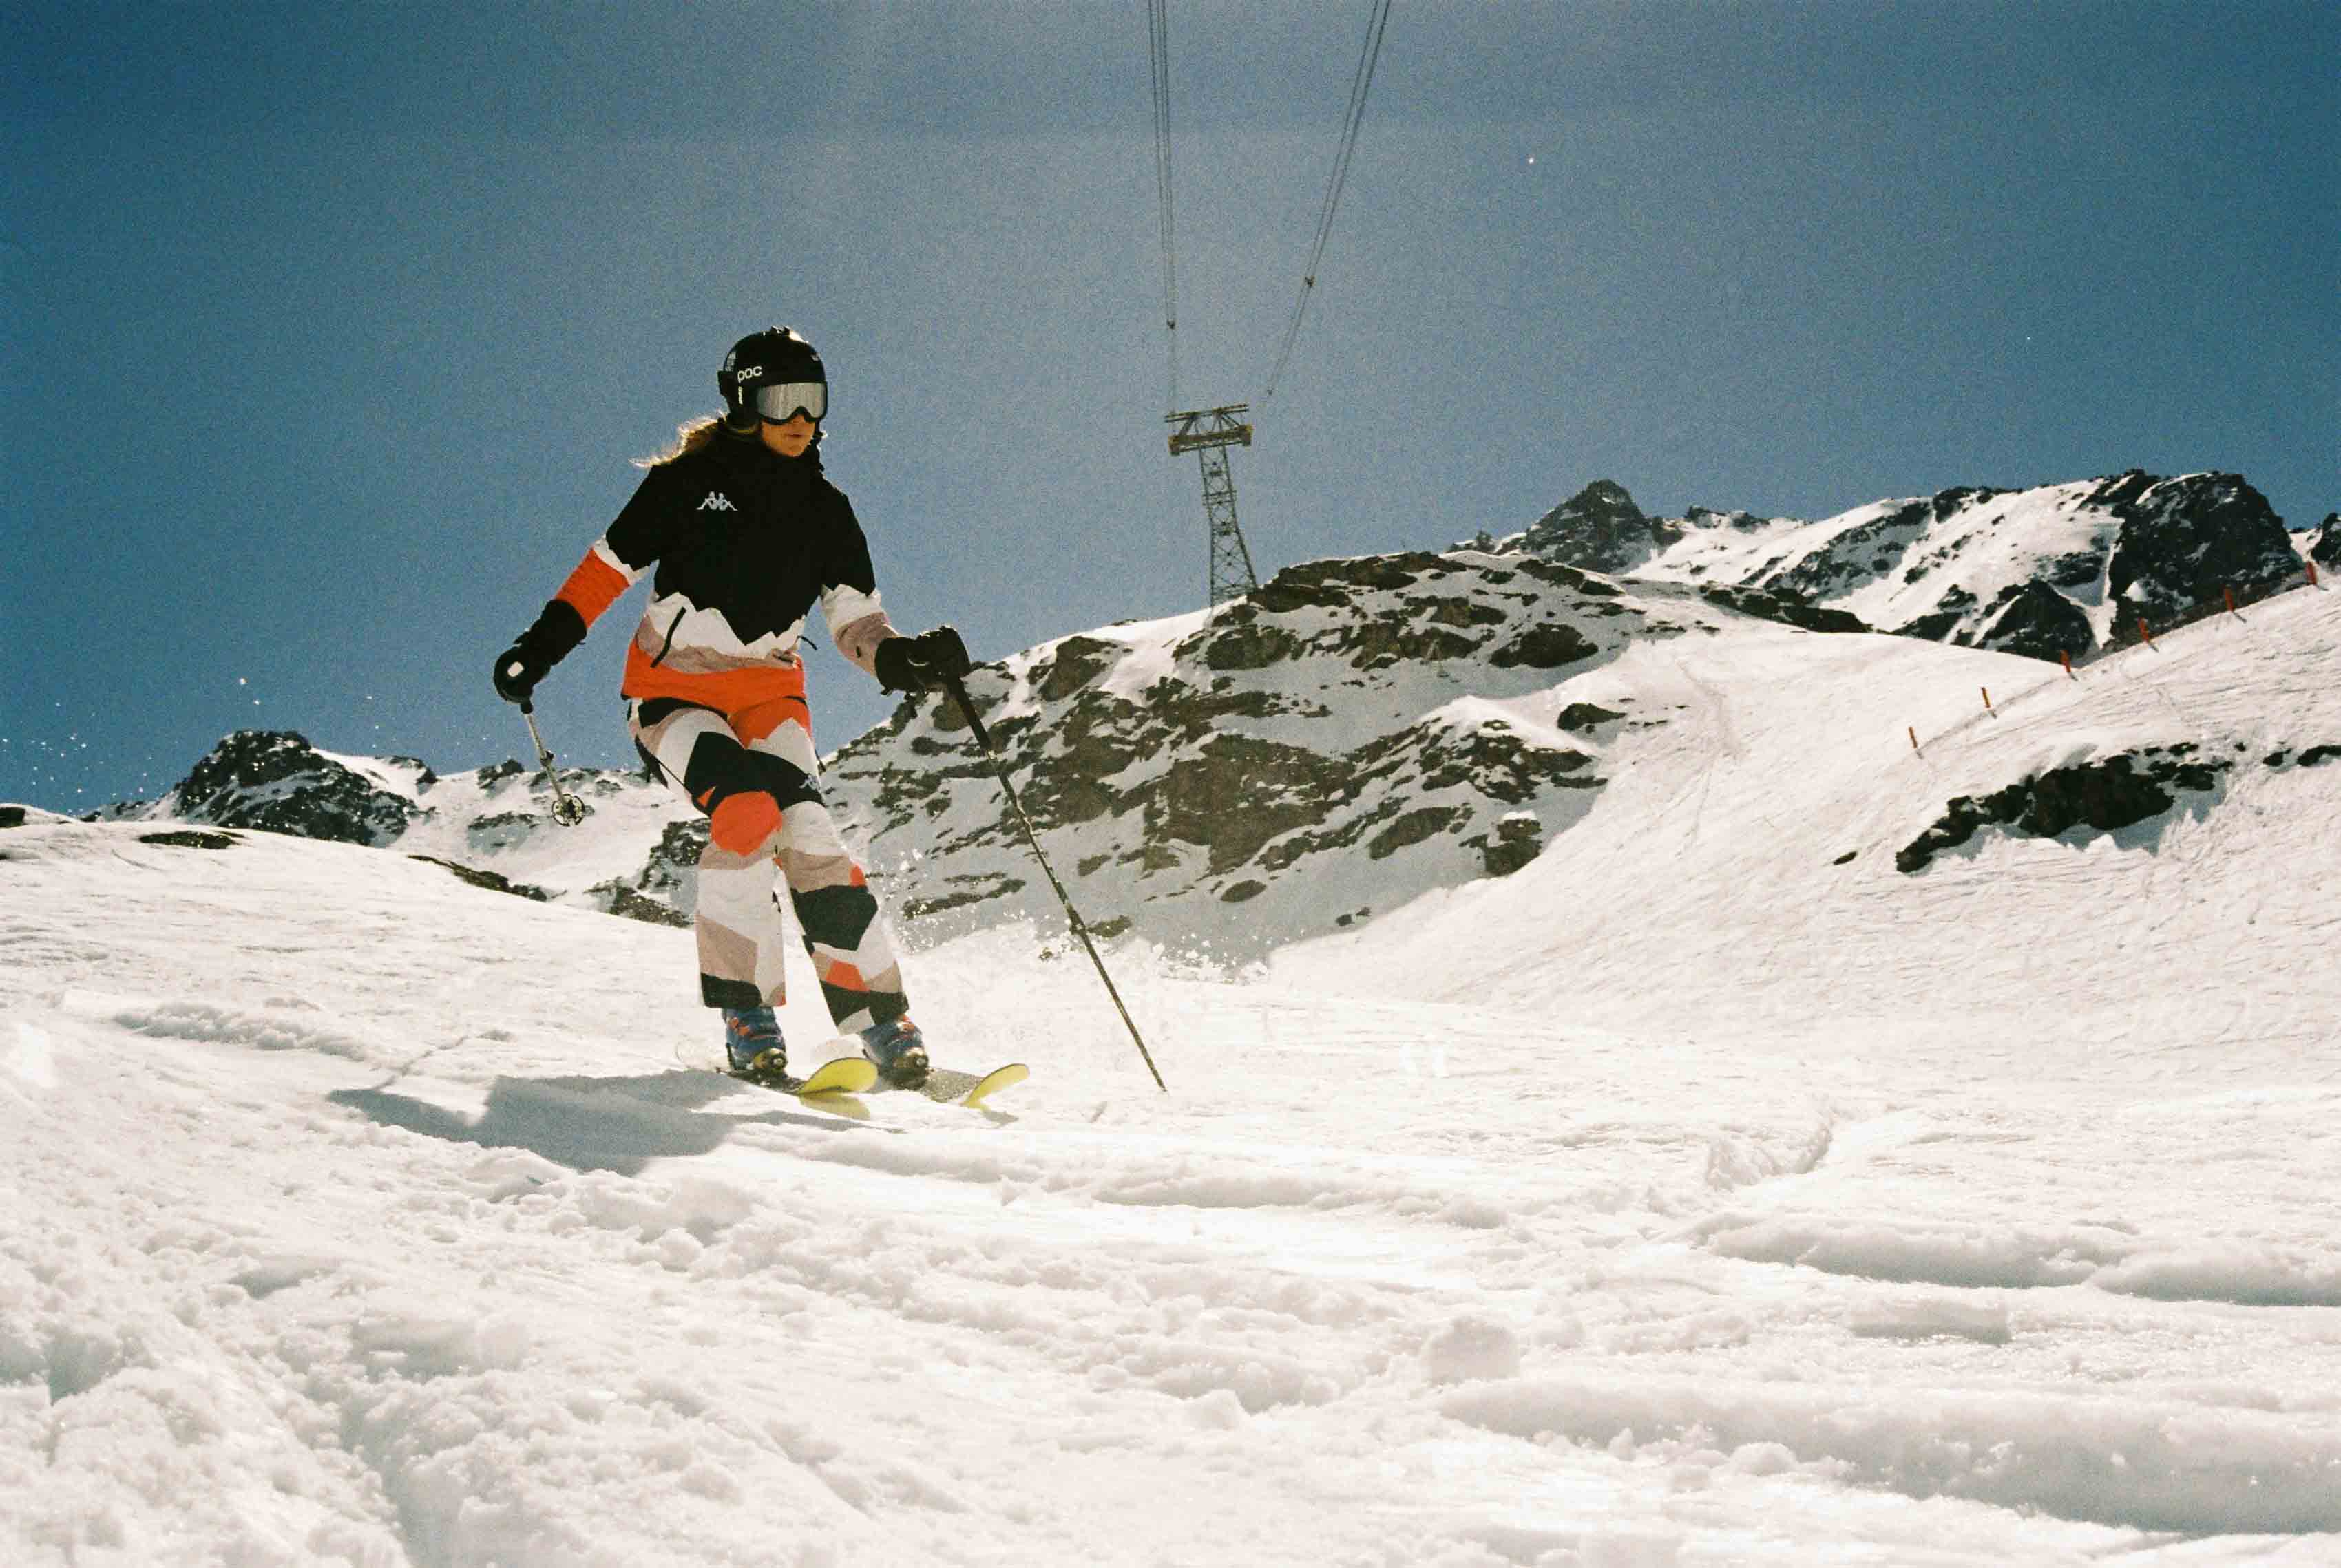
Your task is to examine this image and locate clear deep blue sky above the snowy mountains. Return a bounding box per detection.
[0,0,2341,809]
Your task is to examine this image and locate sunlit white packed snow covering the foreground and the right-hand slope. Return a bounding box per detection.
[13,592,2341,1568]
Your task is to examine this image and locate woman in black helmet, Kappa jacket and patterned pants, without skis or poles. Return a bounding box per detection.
[496,328,972,1086]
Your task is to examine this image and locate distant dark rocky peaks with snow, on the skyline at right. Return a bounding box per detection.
[1510,470,2301,660]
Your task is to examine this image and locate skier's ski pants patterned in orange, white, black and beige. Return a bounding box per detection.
[627,697,908,1035]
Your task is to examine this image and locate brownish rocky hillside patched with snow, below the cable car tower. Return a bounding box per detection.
[824,550,1878,960]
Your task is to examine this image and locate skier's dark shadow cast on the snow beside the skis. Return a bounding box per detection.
[326,1070,890,1175]
